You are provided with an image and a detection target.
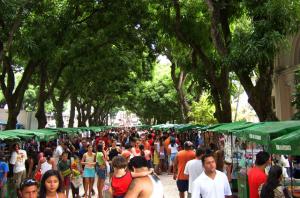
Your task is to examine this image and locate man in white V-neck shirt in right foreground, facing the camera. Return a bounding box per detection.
[192,154,232,198]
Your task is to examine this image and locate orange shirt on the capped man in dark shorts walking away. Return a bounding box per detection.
[177,150,196,180]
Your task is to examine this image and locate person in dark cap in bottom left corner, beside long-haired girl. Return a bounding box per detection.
[19,178,38,198]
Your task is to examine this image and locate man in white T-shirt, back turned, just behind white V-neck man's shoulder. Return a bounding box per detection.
[184,148,205,197]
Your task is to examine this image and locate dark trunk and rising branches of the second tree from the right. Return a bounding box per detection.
[173,0,232,122]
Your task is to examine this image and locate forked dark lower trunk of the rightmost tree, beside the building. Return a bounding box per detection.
[235,63,278,122]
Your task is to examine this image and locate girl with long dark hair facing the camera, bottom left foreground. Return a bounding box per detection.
[40,170,66,198]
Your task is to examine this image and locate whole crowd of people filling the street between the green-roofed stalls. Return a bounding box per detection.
[0,128,296,198]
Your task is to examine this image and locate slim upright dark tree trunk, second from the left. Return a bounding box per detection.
[35,65,48,129]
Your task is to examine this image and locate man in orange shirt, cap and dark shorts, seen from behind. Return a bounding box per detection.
[173,141,196,198]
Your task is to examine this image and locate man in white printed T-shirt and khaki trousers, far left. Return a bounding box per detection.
[10,144,27,189]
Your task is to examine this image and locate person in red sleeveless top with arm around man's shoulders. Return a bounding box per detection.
[110,156,152,198]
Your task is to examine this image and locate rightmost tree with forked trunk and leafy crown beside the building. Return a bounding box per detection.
[229,0,300,121]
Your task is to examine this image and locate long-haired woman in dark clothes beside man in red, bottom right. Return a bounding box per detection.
[260,166,289,198]
